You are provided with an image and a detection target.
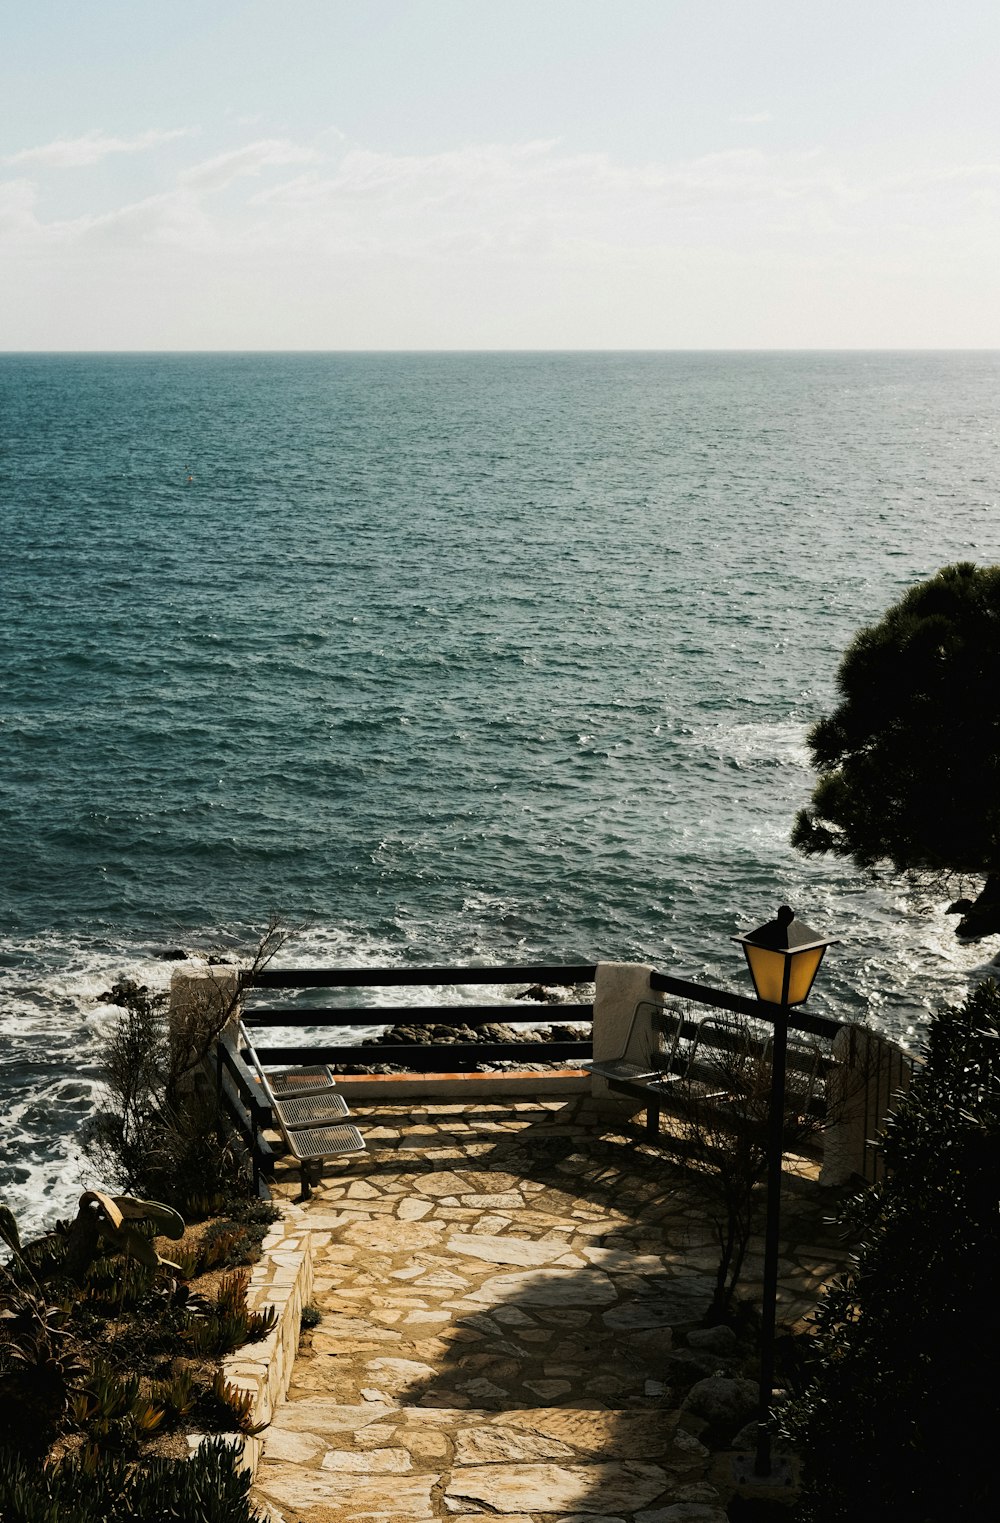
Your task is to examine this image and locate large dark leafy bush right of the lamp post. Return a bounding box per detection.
[785,982,1000,1523]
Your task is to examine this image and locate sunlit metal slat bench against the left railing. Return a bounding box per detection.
[239,1022,365,1200]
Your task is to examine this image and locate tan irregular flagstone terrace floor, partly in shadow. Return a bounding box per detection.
[254,1097,842,1523]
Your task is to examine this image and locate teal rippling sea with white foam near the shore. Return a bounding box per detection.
[0,352,1000,1228]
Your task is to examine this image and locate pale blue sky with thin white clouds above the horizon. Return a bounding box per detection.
[0,0,1000,350]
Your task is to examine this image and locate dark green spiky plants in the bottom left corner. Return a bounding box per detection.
[0,1439,263,1523]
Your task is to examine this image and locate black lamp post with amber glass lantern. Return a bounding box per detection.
[734,905,836,1476]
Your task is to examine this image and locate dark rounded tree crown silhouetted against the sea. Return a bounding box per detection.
[791,562,1000,874]
